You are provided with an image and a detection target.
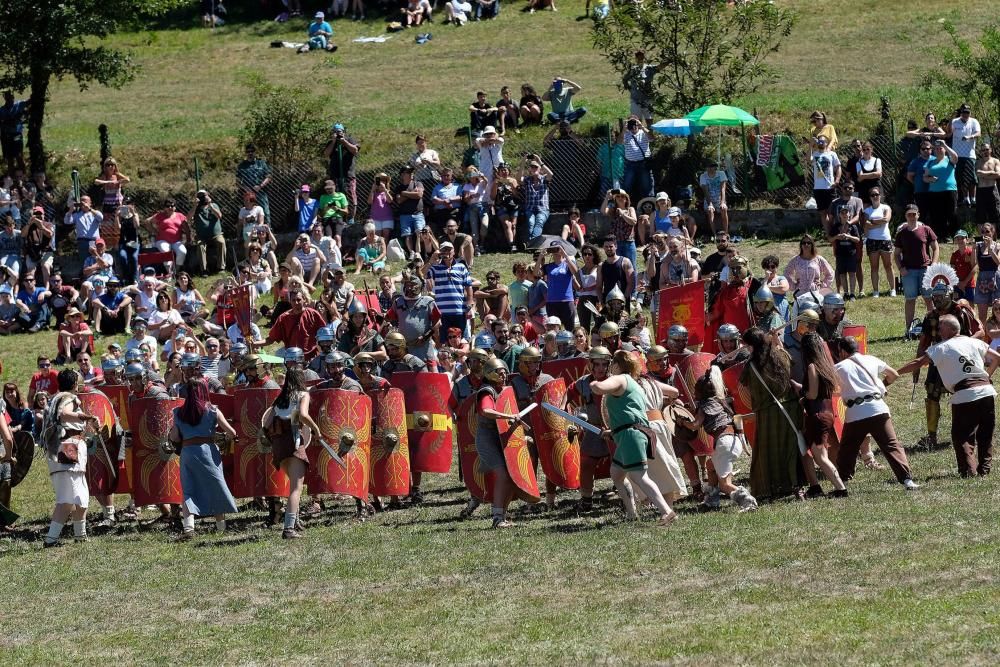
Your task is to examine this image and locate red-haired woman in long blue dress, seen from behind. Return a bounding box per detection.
[167,377,237,540]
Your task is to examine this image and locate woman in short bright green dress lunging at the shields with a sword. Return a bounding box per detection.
[590,350,677,526]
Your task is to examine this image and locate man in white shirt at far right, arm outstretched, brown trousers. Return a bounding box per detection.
[896,315,1000,477]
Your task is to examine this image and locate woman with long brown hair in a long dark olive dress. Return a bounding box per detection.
[740,327,804,498]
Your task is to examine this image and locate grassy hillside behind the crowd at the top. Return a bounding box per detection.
[37,0,995,187]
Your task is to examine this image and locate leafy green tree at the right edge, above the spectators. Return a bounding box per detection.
[925,21,1000,142]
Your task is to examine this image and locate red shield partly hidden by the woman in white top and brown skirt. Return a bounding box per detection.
[227,389,290,498]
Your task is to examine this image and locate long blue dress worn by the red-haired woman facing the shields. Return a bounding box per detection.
[173,408,237,516]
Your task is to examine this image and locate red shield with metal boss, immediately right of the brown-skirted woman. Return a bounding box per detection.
[306,389,372,500]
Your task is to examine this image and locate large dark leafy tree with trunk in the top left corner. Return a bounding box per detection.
[0,0,185,171]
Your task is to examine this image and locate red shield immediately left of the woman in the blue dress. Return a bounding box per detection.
[128,398,184,506]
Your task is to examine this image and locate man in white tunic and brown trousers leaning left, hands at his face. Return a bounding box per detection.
[830,336,918,491]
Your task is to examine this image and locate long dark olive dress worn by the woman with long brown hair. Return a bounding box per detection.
[740,366,804,498]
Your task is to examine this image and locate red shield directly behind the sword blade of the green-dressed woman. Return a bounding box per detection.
[530,378,580,489]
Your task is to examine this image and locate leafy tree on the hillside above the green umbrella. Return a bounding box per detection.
[591,0,795,117]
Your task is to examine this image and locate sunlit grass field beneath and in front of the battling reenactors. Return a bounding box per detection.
[0,241,1000,665]
